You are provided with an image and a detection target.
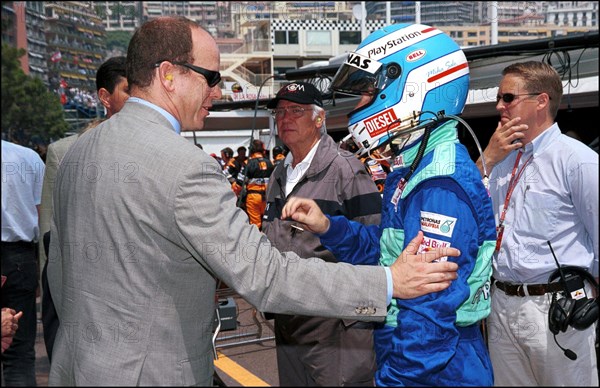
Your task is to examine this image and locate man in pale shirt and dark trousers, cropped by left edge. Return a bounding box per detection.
[0,140,45,387]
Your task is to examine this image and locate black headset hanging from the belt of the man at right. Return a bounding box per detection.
[548,266,598,335]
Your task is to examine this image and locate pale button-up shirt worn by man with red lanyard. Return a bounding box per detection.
[490,124,599,284]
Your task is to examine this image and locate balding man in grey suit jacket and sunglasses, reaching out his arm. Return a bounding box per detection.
[48,17,460,386]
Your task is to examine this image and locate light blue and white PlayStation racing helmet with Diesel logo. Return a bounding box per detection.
[331,24,469,155]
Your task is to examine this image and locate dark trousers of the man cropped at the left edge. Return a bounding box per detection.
[0,242,38,387]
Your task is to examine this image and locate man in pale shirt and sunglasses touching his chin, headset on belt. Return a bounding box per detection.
[478,61,598,386]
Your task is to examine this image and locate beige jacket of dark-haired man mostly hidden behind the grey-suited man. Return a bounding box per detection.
[38,134,79,273]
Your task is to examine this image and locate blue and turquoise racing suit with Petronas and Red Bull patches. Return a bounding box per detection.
[320,122,496,386]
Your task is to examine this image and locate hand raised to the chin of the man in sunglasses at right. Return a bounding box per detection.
[477,117,529,176]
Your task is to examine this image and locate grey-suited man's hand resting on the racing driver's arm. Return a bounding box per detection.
[390,231,460,299]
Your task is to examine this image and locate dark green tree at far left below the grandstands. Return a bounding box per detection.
[1,44,68,146]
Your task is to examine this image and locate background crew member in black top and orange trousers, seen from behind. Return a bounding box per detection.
[234,139,273,229]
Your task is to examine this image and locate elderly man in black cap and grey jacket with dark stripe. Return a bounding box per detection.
[263,82,381,386]
